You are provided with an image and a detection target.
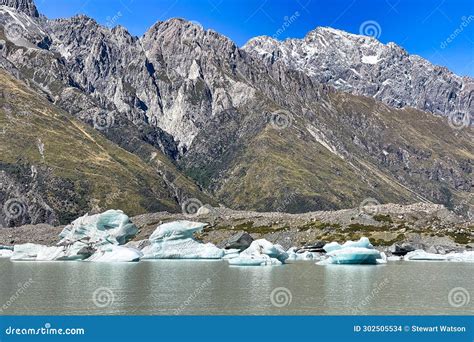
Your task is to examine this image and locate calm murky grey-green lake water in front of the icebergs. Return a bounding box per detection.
[0,259,474,315]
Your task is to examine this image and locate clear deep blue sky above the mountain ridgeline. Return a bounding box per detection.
[36,0,474,77]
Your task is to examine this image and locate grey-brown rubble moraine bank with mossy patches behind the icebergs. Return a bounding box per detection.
[0,203,474,254]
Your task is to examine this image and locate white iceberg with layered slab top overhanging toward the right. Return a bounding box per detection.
[142,221,225,259]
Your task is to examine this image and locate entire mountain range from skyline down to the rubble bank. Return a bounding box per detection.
[0,0,474,230]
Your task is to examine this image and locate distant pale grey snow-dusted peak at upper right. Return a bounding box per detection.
[243,27,474,119]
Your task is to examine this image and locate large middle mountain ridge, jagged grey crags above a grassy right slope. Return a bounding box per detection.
[0,2,474,224]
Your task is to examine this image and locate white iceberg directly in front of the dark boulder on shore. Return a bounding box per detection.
[228,239,288,266]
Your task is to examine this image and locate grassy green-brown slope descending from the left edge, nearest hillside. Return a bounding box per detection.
[0,70,210,226]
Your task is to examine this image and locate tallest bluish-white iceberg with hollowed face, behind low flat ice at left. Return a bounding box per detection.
[59,210,138,245]
